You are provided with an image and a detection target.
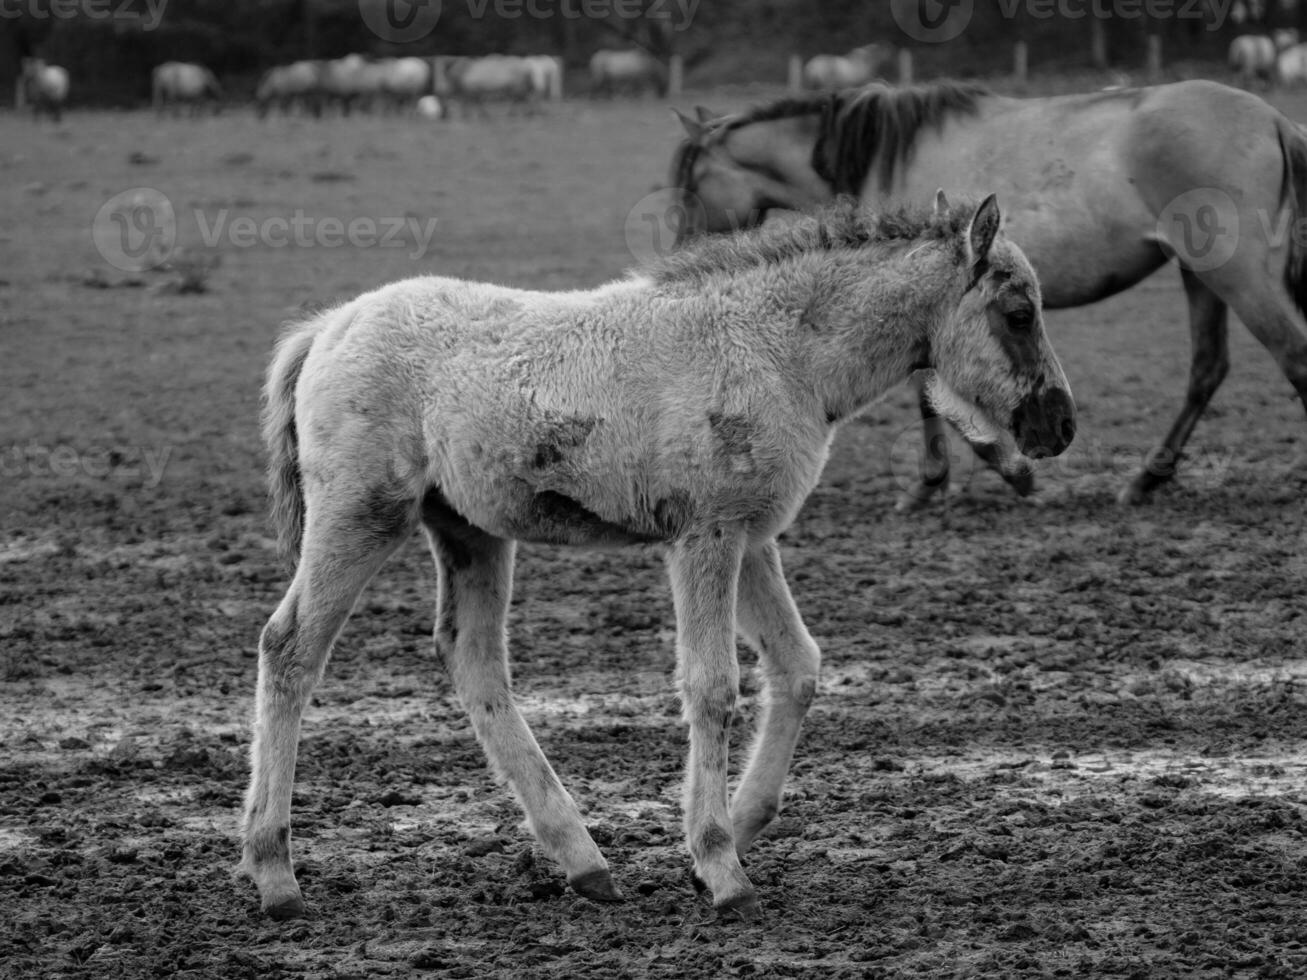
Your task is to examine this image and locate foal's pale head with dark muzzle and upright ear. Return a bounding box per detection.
[925,191,1076,473]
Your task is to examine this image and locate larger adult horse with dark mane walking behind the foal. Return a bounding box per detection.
[672,81,1307,507]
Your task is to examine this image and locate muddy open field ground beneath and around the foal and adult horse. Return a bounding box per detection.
[0,88,1307,980]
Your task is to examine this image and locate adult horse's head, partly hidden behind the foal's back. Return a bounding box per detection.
[670,108,831,244]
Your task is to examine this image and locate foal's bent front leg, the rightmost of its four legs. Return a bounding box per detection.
[731,540,821,855]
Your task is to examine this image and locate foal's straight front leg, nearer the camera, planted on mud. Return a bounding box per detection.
[668,525,758,919]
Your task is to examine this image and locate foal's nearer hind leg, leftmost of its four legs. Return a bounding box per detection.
[240,495,412,919]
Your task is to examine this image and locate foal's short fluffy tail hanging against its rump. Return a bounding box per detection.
[263,318,318,566]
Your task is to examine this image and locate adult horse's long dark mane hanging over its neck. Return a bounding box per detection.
[813,82,991,195]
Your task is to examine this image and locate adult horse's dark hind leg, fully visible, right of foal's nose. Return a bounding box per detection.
[1119,269,1230,503]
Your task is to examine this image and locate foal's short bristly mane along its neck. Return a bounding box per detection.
[639,197,974,285]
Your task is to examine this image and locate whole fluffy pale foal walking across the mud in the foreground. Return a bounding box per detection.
[242,192,1074,919]
